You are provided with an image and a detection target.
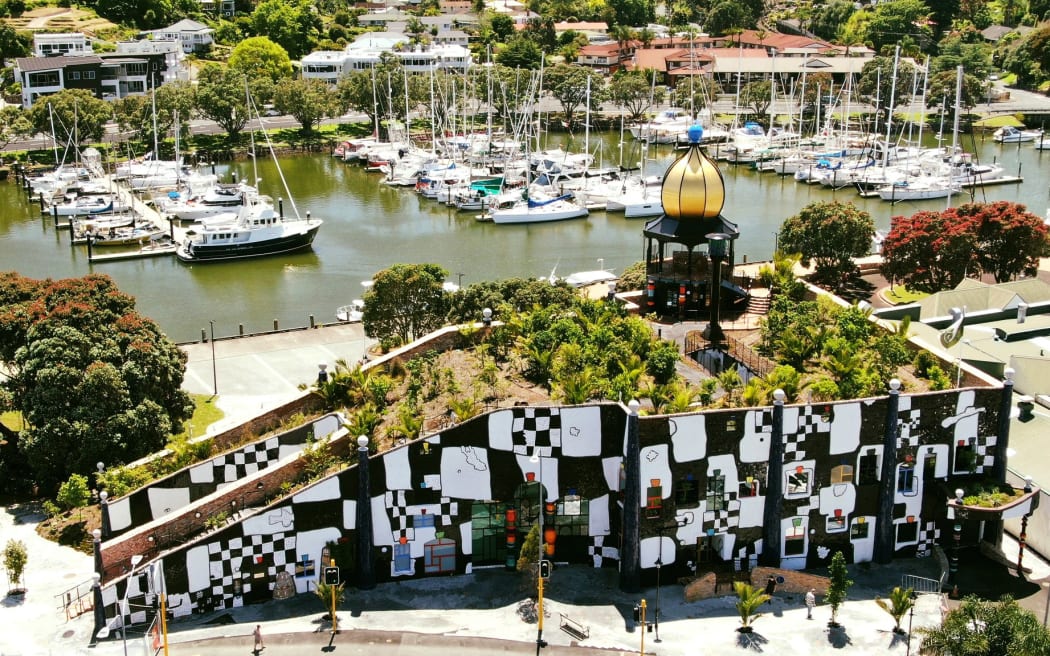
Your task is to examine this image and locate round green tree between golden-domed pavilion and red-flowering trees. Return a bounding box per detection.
[778,200,875,282]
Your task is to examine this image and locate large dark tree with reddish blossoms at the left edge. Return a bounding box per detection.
[0,273,193,492]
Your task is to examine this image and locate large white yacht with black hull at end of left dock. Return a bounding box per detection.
[175,90,323,262]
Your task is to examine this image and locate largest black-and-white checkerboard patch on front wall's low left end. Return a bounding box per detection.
[208,533,295,608]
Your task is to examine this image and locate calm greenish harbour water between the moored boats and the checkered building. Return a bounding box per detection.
[0,129,1050,341]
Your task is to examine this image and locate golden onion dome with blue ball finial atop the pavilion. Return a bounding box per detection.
[660,125,726,221]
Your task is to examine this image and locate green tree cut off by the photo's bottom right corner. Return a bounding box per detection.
[918,596,1050,656]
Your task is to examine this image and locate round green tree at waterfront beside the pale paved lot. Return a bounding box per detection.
[362,264,448,343]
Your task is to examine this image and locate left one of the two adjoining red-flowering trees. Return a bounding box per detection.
[882,208,978,293]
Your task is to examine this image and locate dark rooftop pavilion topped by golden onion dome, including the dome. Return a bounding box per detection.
[643,125,748,329]
